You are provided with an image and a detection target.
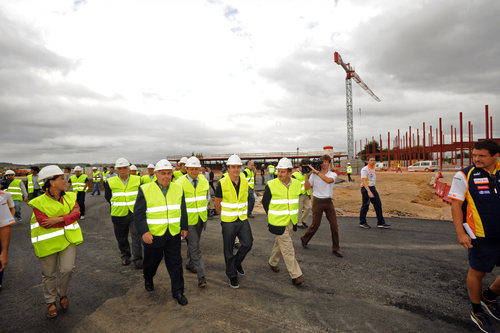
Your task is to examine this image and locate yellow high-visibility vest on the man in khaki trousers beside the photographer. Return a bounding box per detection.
[267,178,301,226]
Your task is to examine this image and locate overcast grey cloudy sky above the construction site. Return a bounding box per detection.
[0,0,500,163]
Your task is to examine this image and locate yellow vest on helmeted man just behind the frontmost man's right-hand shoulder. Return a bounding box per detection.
[177,175,210,225]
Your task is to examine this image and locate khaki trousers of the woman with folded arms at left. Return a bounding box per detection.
[39,244,76,304]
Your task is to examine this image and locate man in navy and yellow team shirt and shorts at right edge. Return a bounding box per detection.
[448,139,500,332]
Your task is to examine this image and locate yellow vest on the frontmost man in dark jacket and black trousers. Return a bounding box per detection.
[141,182,183,236]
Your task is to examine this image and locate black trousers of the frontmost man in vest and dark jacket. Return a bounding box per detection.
[142,231,184,297]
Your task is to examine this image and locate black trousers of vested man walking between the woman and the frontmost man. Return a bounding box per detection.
[111,211,142,261]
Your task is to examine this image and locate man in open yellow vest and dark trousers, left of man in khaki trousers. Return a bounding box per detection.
[215,155,253,288]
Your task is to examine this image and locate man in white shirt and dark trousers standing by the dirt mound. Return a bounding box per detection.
[359,156,391,229]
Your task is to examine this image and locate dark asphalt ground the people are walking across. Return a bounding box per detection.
[0,194,490,332]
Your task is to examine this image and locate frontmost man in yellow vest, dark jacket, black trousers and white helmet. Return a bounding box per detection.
[134,159,189,305]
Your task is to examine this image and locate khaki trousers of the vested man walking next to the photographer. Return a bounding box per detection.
[269,222,302,279]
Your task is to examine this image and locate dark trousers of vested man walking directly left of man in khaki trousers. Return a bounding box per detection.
[221,220,253,278]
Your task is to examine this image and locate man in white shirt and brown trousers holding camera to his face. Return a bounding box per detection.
[301,155,344,258]
